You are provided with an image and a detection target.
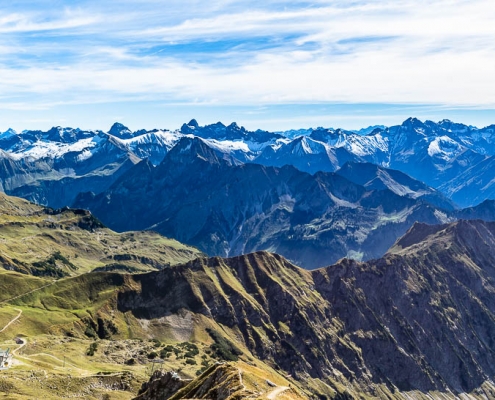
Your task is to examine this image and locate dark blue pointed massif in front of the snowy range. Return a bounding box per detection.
[74,138,495,268]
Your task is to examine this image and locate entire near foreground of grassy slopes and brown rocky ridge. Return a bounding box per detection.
[0,191,495,399]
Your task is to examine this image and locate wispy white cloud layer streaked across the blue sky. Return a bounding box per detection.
[0,0,495,124]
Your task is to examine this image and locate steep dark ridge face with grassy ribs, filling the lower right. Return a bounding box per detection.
[118,221,495,397]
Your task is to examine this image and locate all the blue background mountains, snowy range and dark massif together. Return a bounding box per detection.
[0,118,495,268]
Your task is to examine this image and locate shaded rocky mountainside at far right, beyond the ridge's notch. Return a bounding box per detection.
[313,221,495,393]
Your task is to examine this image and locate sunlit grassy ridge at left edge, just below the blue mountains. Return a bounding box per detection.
[0,194,200,278]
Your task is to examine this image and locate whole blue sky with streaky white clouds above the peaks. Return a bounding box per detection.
[0,0,495,131]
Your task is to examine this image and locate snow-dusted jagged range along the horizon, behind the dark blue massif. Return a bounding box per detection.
[0,118,495,207]
